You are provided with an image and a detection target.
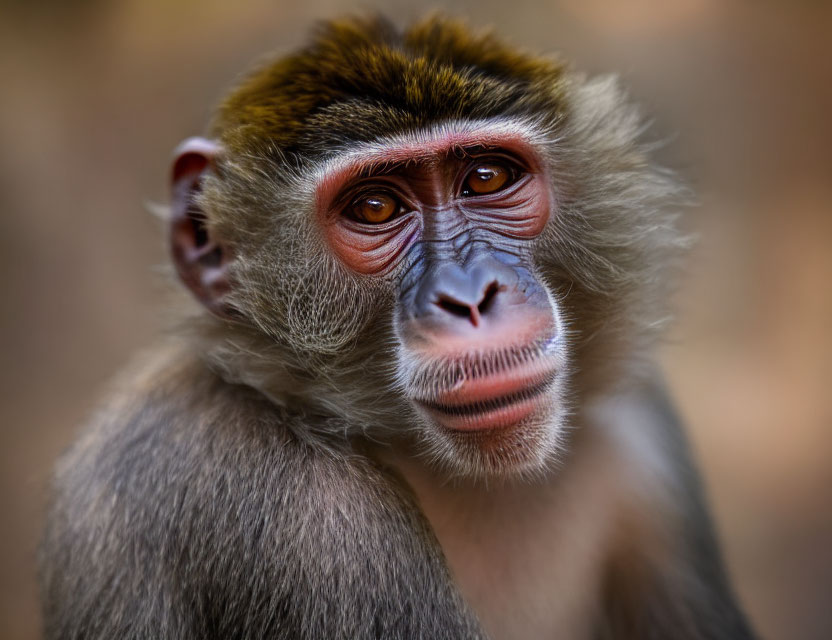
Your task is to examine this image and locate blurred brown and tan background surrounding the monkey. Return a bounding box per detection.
[0,0,832,640]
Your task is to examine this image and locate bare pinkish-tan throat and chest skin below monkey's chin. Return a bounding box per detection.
[368,416,625,638]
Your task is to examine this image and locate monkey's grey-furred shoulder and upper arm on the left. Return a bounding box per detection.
[43,350,488,638]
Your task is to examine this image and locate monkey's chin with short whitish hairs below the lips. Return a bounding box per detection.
[421,404,563,480]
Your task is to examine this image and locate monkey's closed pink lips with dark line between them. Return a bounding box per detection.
[415,368,557,431]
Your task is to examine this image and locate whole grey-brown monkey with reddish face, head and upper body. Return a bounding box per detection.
[40,16,754,640]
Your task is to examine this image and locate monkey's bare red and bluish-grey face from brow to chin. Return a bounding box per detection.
[317,123,565,475]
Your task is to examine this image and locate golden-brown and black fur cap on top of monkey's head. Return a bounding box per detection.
[212,17,564,158]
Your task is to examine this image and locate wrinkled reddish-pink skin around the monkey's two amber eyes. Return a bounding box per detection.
[317,131,551,275]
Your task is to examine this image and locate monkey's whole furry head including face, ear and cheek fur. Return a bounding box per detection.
[171,19,680,477]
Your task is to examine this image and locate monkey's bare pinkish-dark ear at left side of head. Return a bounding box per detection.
[169,138,232,318]
